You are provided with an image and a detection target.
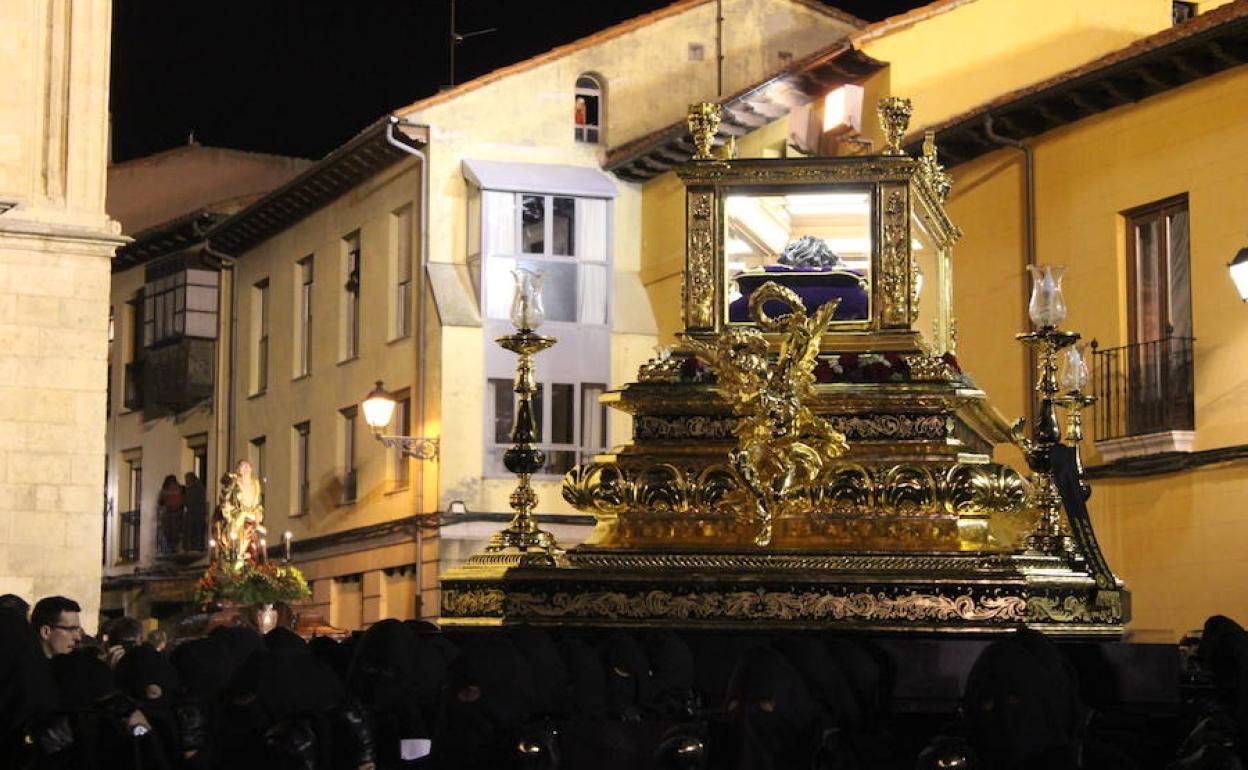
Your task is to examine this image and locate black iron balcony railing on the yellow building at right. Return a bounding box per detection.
[1092,337,1196,441]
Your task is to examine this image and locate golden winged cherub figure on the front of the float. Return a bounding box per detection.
[688,281,847,545]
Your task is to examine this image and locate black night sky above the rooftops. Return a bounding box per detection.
[111,0,924,161]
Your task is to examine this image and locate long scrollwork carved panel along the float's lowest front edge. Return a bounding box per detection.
[507,588,1027,624]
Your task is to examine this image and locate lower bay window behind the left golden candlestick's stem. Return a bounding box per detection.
[488,377,607,475]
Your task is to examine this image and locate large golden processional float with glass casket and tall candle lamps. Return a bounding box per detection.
[442,97,1128,636]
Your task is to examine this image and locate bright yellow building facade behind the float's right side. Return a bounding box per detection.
[641,0,1248,640]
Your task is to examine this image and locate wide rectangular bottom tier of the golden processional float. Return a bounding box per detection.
[442,548,1128,638]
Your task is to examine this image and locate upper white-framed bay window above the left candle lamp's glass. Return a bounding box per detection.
[484,192,610,326]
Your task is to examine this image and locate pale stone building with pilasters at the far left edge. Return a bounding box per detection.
[0,0,122,629]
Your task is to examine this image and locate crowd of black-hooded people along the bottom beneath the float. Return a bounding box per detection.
[0,600,1248,770]
